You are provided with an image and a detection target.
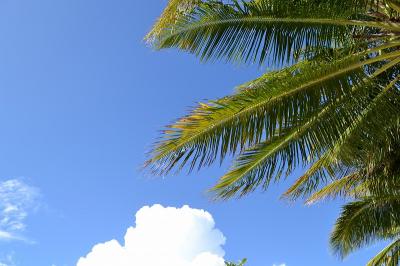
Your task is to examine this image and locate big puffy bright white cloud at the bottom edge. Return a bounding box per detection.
[77,205,225,266]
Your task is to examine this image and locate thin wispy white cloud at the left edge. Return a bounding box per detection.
[0,179,40,241]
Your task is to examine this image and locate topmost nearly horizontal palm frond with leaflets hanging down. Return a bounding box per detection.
[155,0,400,64]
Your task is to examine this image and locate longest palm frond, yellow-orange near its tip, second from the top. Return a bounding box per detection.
[148,51,400,177]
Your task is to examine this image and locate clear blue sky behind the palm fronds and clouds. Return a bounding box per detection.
[0,0,390,266]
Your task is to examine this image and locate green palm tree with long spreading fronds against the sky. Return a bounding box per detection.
[147,0,400,265]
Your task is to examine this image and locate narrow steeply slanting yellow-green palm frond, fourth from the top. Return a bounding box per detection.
[285,66,400,199]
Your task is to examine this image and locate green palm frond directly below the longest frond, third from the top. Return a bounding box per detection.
[214,89,362,198]
